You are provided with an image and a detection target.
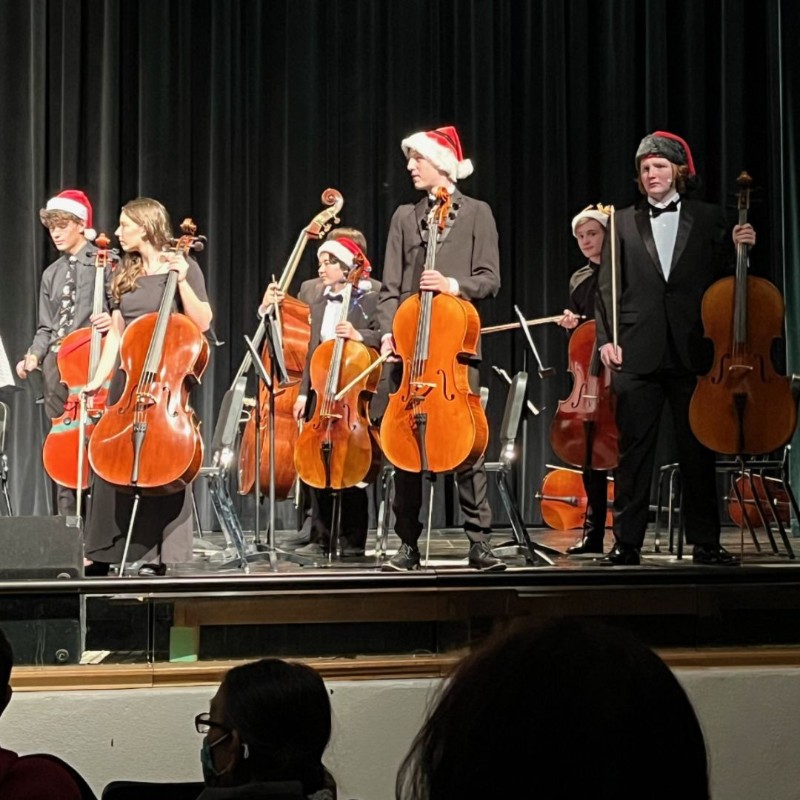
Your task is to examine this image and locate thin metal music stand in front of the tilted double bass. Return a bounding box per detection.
[244,332,314,571]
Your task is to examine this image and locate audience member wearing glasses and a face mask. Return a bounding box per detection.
[195,658,336,800]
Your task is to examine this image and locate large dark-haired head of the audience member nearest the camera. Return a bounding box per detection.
[396,620,709,800]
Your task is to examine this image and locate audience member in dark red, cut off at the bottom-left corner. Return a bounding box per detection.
[0,630,94,800]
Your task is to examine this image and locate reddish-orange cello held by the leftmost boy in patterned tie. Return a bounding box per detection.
[42,233,113,489]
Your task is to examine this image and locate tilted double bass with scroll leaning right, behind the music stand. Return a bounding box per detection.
[231,189,344,499]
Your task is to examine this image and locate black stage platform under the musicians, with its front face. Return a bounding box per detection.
[0,529,800,664]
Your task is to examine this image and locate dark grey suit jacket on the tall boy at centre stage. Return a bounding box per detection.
[377,189,500,336]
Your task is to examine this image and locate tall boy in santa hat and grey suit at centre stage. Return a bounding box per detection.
[378,126,505,571]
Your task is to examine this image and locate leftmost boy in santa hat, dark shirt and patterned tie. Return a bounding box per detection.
[16,189,111,514]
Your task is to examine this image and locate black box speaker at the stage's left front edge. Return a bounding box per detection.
[0,517,83,578]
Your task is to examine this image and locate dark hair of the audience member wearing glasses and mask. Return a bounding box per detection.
[221,658,331,794]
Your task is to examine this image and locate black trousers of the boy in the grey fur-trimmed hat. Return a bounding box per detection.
[612,368,720,547]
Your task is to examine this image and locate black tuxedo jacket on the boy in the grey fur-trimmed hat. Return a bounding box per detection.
[596,198,733,375]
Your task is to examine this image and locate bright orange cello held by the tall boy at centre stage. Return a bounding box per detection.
[380,188,489,473]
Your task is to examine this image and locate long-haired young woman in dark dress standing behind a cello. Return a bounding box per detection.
[85,197,212,575]
